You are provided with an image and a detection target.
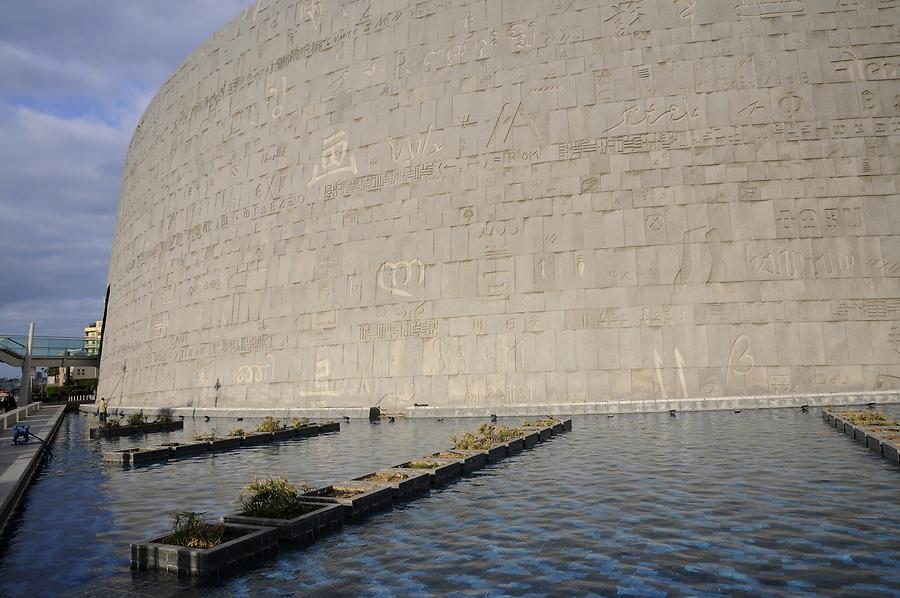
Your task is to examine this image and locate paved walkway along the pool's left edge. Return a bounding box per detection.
[0,405,66,530]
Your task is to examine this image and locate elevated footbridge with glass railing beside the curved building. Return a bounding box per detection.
[0,335,100,368]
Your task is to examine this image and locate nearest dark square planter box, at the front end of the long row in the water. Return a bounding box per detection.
[131,524,278,579]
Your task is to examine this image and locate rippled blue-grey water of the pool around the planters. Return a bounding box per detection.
[0,408,900,596]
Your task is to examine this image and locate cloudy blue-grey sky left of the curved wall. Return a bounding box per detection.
[0,0,252,376]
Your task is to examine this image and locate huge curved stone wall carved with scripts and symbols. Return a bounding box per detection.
[100,0,900,410]
